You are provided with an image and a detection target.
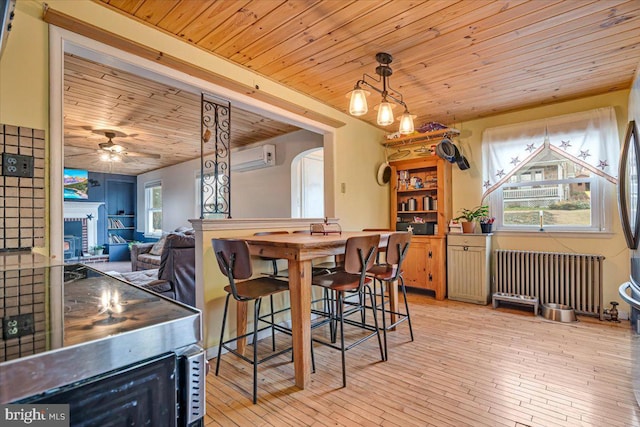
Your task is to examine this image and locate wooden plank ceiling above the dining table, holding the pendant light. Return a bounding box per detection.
[95,0,640,132]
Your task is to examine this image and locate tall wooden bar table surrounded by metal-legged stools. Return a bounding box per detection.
[237,231,390,389]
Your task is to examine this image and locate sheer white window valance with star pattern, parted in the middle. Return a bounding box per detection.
[482,107,620,199]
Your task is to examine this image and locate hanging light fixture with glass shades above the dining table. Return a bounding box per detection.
[347,52,415,135]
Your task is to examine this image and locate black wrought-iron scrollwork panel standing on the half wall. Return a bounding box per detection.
[200,94,231,219]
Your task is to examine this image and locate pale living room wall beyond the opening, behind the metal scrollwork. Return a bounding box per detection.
[136,130,323,232]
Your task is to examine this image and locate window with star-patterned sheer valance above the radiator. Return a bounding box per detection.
[482,108,620,232]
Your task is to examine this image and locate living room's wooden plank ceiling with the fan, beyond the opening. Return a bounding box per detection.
[64,54,298,175]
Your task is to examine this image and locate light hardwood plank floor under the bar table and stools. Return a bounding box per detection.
[205,294,640,426]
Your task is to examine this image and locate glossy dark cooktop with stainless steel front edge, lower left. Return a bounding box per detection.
[0,265,201,403]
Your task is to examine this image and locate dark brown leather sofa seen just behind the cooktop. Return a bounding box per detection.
[114,232,196,306]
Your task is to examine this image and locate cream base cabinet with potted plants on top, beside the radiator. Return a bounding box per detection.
[447,234,491,305]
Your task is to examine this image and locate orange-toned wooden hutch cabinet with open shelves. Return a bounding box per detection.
[389,132,451,300]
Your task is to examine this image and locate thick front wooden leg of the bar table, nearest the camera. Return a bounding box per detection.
[289,260,311,389]
